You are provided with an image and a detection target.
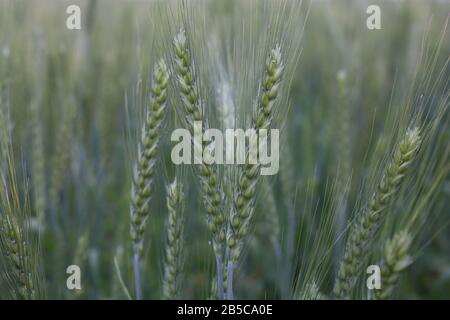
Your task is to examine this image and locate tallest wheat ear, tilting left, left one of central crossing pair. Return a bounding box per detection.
[173,30,226,299]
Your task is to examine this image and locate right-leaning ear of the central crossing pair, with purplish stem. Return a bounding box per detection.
[227,45,284,299]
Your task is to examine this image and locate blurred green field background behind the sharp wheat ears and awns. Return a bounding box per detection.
[0,0,450,299]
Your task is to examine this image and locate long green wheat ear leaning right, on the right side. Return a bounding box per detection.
[334,127,421,298]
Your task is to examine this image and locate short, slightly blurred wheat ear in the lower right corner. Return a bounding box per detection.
[374,230,413,300]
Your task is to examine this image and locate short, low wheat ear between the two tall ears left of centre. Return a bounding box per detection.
[163,178,184,300]
